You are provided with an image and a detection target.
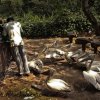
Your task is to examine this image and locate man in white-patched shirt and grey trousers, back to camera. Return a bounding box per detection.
[4,17,30,76]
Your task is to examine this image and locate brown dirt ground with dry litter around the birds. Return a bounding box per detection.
[0,38,100,100]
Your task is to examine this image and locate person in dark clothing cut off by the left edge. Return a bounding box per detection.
[0,18,10,75]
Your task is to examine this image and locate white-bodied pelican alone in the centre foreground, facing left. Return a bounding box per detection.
[46,70,71,92]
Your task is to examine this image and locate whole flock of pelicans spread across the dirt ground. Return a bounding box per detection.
[28,37,100,92]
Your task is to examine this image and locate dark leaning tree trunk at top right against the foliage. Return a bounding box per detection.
[81,0,100,36]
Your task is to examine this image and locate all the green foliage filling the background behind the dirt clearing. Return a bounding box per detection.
[0,0,100,38]
